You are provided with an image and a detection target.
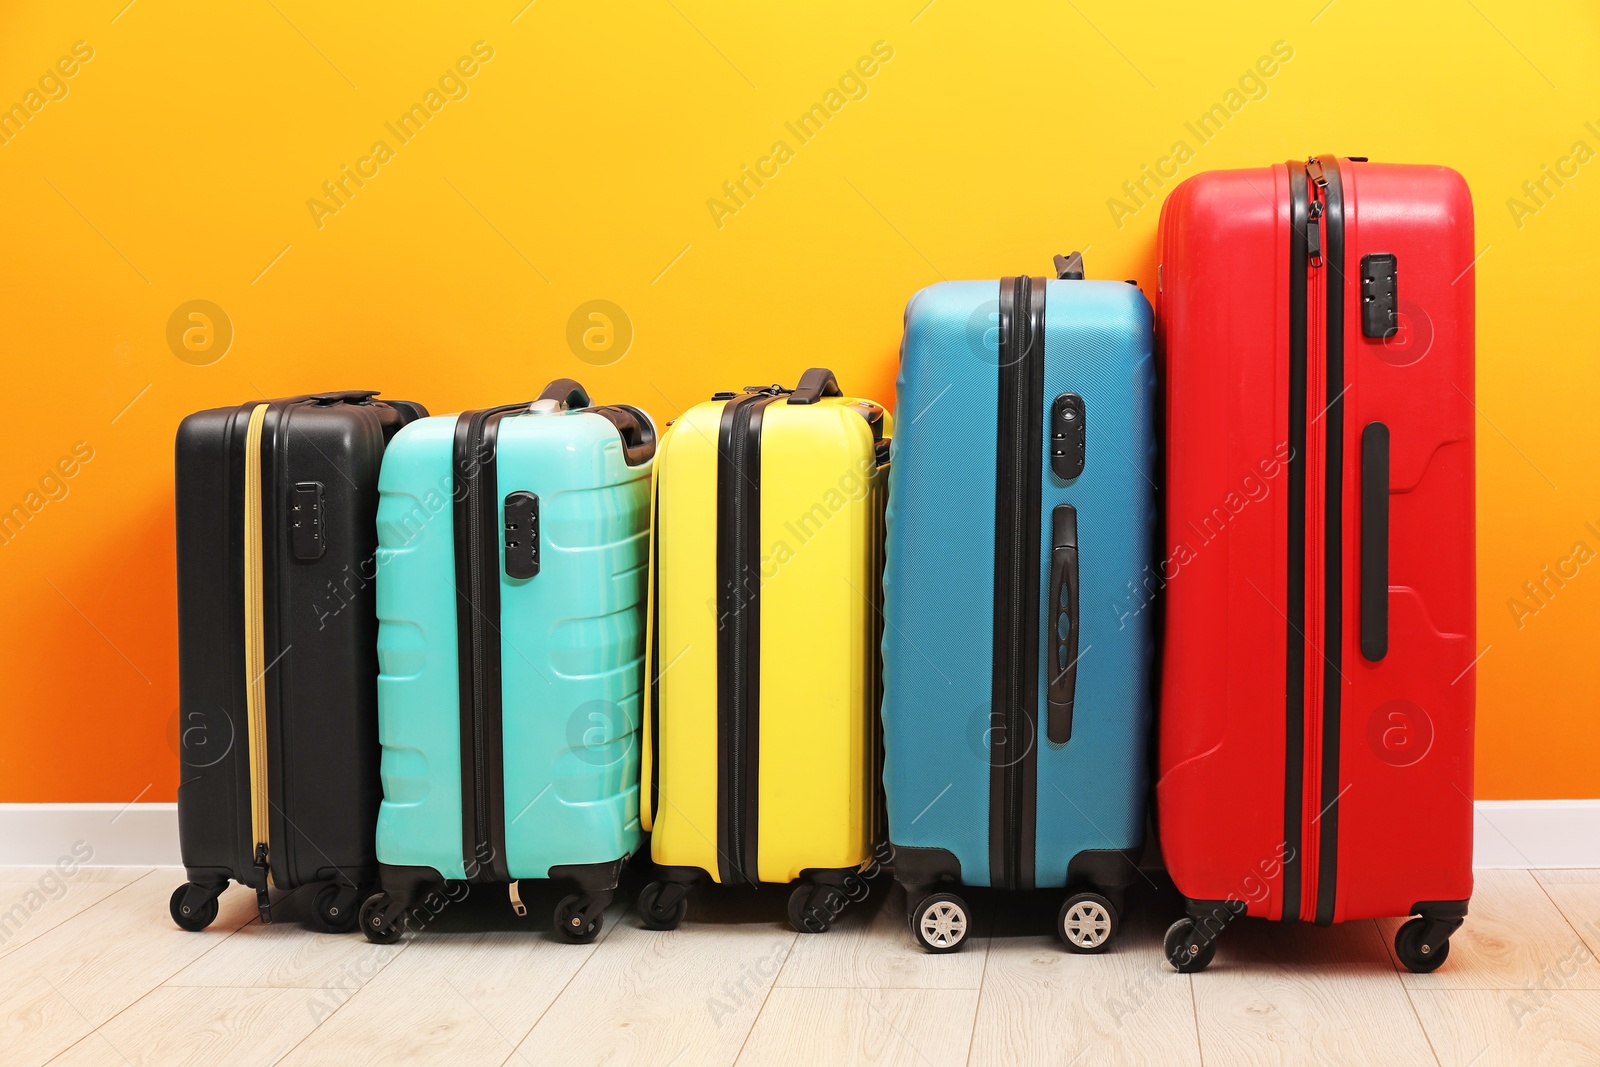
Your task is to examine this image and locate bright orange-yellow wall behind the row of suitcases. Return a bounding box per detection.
[0,0,1600,801]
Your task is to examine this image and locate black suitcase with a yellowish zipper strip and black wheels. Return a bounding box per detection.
[170,390,427,929]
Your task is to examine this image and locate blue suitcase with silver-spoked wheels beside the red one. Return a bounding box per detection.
[883,254,1157,952]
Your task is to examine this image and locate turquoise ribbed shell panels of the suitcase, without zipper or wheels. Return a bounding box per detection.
[378,399,650,878]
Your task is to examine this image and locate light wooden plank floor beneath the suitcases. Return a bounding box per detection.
[0,869,1600,1067]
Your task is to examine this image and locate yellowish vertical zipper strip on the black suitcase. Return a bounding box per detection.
[245,403,272,923]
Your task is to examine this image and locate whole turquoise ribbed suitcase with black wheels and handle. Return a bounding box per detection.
[362,379,656,942]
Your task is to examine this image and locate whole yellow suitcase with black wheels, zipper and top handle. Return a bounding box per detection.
[640,368,891,933]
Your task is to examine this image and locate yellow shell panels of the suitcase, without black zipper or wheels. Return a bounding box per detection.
[645,388,890,883]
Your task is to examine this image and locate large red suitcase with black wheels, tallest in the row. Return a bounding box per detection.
[1152,155,1477,971]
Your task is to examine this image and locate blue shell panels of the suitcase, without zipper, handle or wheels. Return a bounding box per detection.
[883,280,1157,904]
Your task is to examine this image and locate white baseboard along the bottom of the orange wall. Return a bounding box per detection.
[0,800,1600,867]
